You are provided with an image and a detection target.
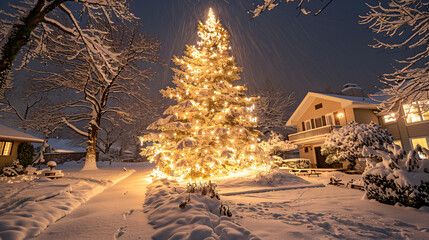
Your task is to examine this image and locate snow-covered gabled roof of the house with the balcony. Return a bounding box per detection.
[286,92,377,126]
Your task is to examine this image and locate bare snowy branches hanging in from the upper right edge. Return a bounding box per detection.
[360,0,429,111]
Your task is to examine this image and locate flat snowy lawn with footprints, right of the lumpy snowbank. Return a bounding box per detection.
[223,172,429,239]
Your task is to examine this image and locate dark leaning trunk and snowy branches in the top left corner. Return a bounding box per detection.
[0,0,135,97]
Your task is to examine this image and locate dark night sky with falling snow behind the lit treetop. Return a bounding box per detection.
[0,0,395,100]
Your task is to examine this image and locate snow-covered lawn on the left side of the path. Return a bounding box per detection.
[0,163,134,239]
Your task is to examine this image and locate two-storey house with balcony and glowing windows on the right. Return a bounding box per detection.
[286,83,429,168]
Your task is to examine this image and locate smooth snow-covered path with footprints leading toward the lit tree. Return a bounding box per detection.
[36,169,154,240]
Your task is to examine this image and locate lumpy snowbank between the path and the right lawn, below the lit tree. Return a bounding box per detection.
[144,179,259,240]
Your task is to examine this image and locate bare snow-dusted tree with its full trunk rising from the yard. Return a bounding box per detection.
[33,22,159,170]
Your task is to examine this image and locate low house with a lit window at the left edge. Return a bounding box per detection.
[0,124,43,169]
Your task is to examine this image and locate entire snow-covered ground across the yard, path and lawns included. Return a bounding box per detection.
[0,162,429,240]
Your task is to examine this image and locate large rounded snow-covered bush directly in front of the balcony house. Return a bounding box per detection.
[321,122,393,169]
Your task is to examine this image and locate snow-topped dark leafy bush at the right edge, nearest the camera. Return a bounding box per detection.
[362,145,429,208]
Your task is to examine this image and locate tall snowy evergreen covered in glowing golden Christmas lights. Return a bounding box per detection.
[143,9,262,181]
